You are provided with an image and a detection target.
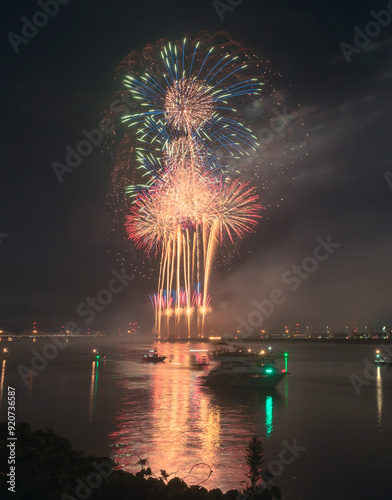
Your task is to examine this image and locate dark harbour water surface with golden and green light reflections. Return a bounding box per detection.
[0,338,392,500]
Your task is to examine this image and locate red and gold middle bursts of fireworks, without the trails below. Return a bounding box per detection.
[127,167,261,252]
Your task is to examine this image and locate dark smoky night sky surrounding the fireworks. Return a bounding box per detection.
[0,0,392,331]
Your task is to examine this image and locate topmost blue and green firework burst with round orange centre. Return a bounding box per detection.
[122,37,264,173]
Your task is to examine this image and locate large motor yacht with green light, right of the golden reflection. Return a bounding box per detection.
[204,359,288,388]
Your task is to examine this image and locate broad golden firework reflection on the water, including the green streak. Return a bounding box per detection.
[110,345,279,488]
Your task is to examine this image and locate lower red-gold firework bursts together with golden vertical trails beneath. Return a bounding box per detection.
[127,162,260,338]
